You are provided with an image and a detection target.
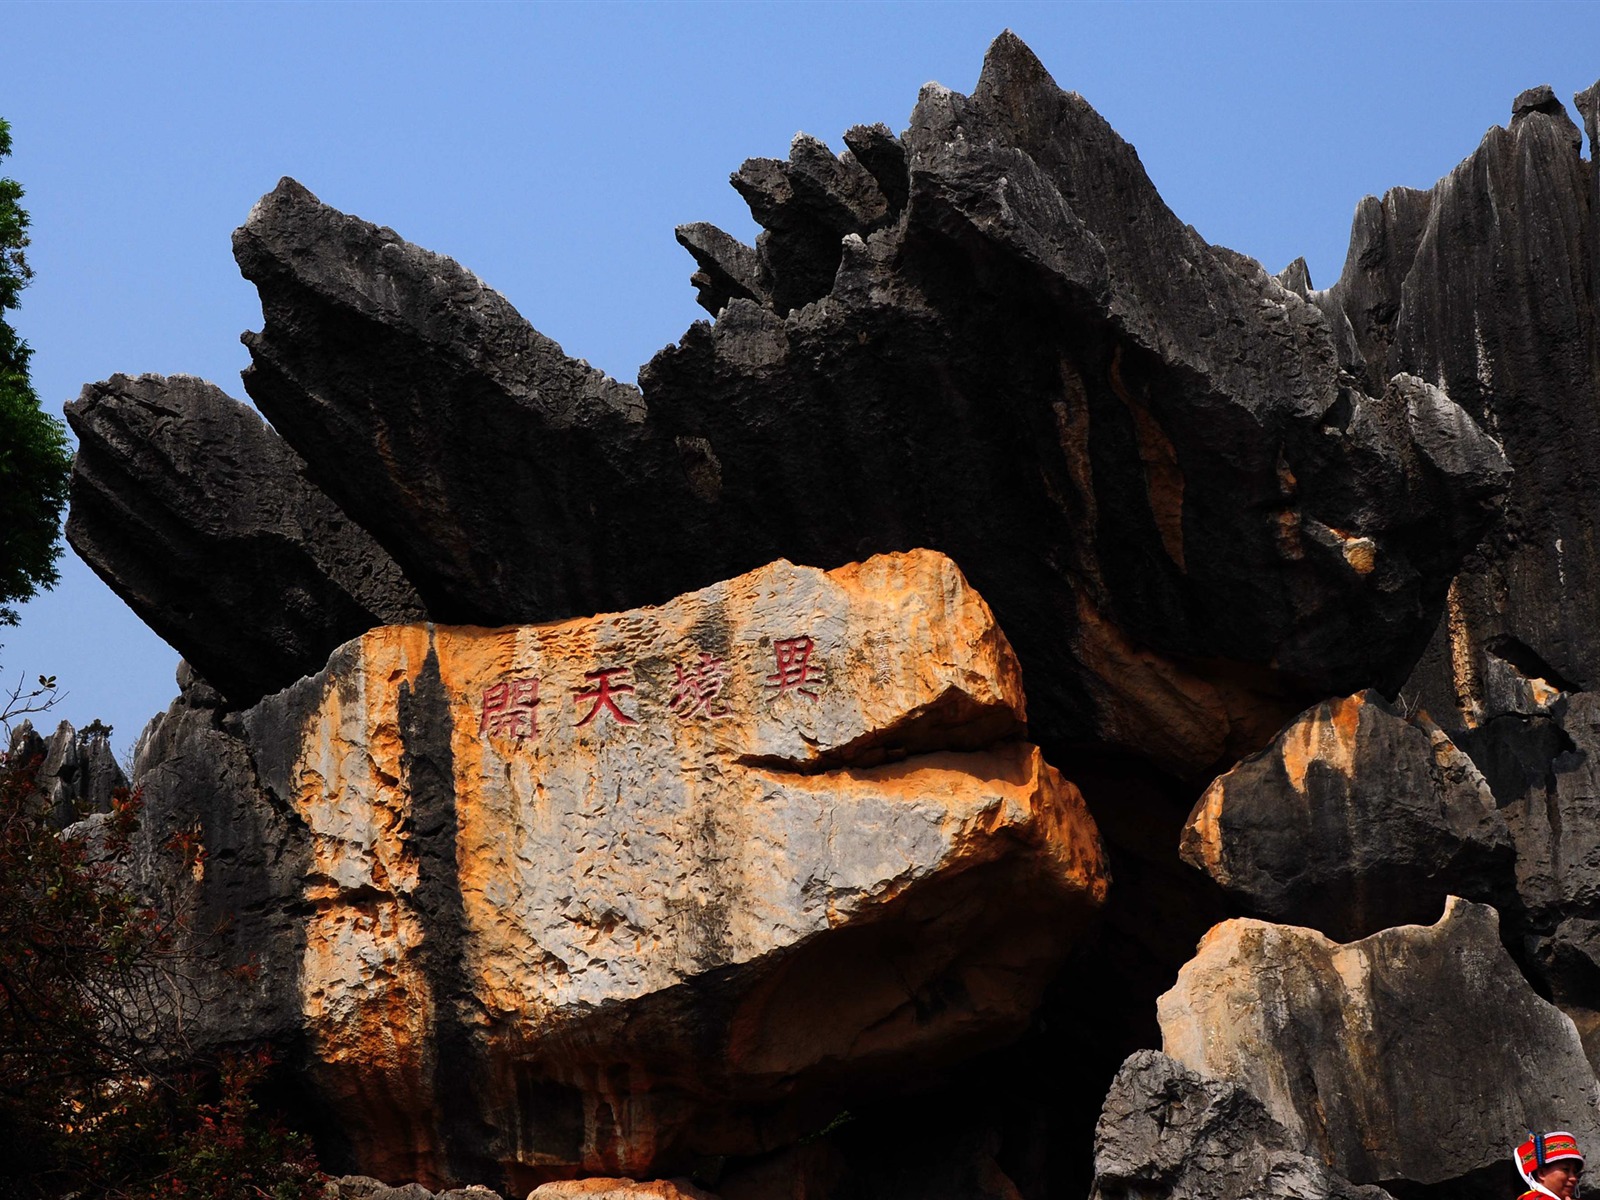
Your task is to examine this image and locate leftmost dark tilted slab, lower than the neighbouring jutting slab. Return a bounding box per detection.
[66,374,424,704]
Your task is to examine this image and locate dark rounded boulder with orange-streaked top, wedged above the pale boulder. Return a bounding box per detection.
[1181,691,1517,941]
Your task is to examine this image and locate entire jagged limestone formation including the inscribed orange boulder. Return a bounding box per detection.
[74,25,1600,1200]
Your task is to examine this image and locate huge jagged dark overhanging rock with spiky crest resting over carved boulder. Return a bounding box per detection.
[216,35,1506,776]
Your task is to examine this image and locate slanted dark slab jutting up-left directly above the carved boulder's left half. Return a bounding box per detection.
[228,179,659,630]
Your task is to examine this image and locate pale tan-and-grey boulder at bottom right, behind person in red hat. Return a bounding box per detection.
[1158,898,1600,1194]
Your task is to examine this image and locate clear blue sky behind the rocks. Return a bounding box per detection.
[0,2,1600,761]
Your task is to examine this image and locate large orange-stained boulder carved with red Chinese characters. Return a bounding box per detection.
[245,552,1107,1187]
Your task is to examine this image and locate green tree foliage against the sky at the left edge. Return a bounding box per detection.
[0,120,72,626]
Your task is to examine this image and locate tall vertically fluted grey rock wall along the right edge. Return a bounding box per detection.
[1312,77,1600,1043]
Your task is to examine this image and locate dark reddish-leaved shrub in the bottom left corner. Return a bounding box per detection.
[0,754,322,1200]
